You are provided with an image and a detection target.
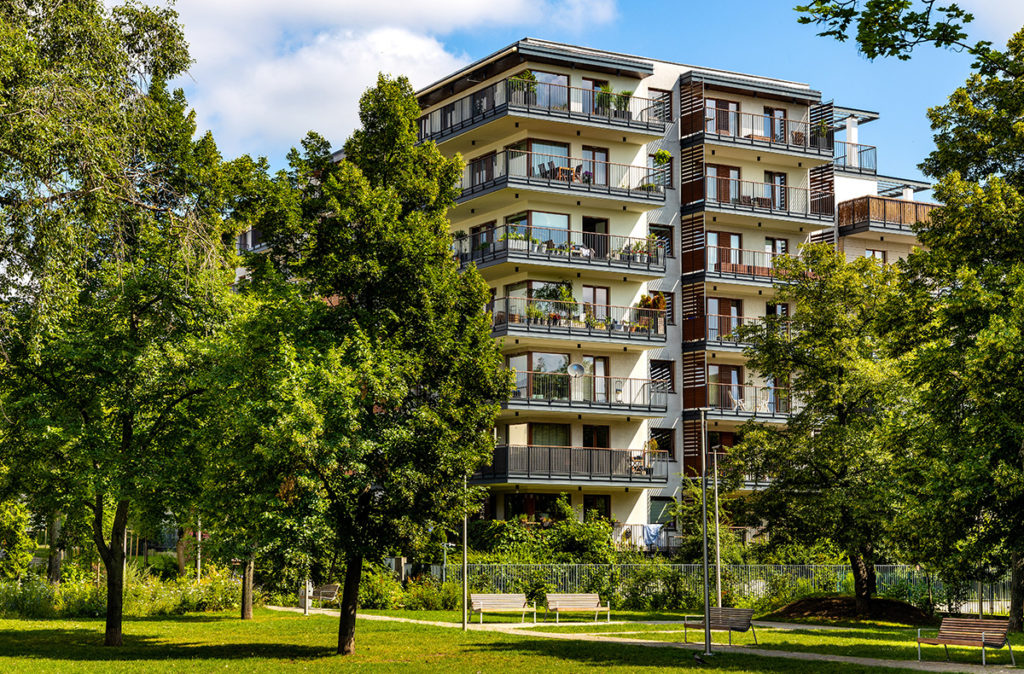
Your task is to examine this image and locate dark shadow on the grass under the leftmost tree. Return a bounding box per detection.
[0,617,334,661]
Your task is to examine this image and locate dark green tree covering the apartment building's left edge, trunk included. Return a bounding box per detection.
[253,76,510,654]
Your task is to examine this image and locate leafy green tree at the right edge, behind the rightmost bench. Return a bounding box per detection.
[894,173,1024,630]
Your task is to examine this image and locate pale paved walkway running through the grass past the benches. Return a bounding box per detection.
[266,606,1021,674]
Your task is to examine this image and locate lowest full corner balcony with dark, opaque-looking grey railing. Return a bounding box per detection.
[472,445,669,485]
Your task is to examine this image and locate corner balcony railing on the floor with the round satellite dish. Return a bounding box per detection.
[512,371,672,410]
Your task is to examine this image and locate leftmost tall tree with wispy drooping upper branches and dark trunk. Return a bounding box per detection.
[0,0,241,645]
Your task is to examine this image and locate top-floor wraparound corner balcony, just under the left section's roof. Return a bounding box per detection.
[419,78,671,142]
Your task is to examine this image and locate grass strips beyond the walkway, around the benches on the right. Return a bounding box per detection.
[534,621,1024,666]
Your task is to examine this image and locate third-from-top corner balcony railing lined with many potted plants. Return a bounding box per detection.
[453,223,665,269]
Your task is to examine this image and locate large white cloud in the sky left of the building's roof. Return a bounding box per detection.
[176,0,615,162]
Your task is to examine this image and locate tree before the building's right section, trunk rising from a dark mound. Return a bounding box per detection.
[730,245,900,615]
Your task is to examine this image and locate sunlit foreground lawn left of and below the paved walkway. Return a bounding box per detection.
[0,609,913,674]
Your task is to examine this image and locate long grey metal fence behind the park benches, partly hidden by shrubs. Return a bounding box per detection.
[429,563,1010,615]
